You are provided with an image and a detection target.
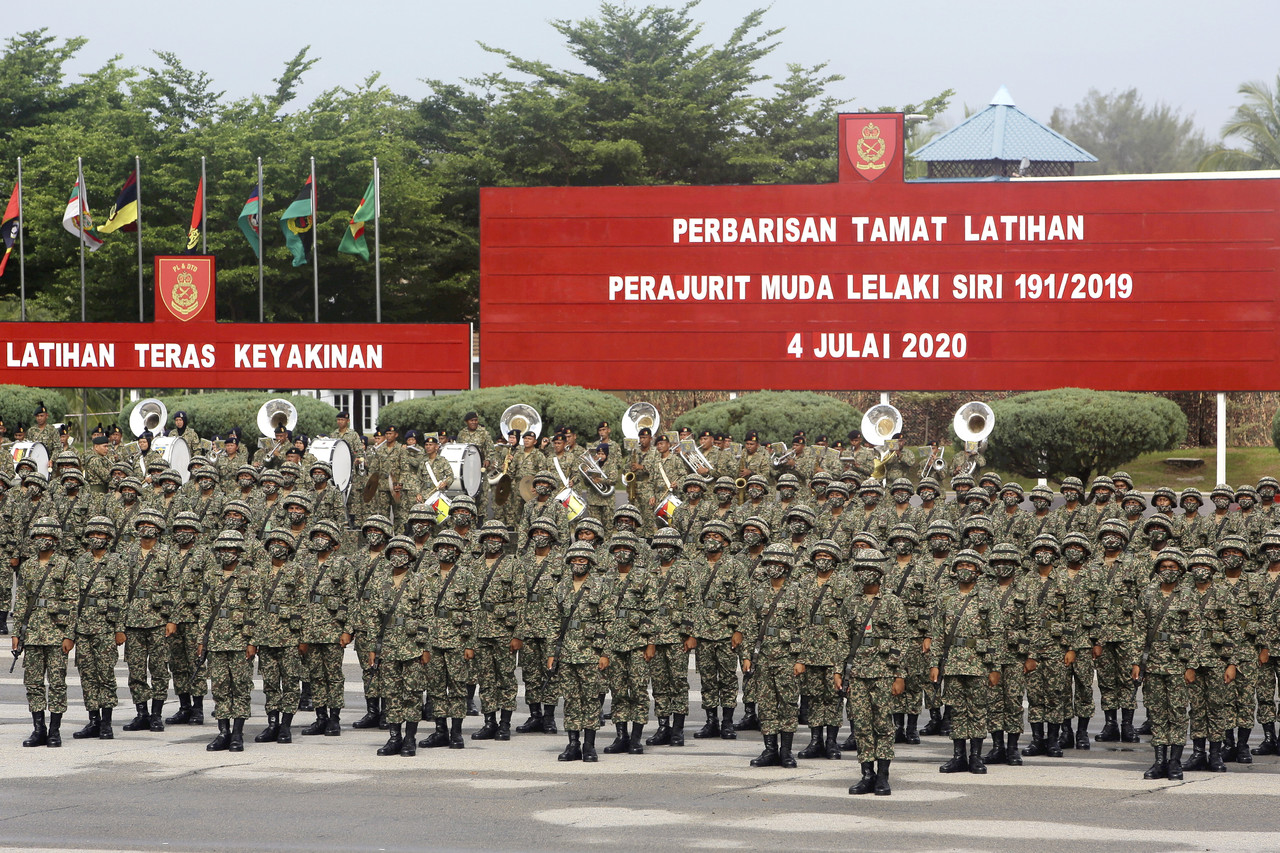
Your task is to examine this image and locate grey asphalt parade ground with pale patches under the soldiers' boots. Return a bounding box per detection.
[0,651,1280,853]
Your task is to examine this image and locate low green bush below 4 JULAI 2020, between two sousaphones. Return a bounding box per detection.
[663,391,863,444]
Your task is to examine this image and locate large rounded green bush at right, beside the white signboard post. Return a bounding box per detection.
[987,388,1187,484]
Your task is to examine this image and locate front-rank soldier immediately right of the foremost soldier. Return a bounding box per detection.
[929,549,1004,774]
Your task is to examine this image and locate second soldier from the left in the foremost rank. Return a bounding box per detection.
[198,530,260,752]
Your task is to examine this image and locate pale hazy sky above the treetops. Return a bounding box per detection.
[5,0,1280,138]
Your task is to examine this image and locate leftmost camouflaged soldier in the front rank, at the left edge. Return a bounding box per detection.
[13,516,79,747]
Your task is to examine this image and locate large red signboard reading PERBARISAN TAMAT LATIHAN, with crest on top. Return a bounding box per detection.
[480,117,1280,391]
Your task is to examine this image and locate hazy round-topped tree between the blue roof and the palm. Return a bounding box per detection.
[1048,88,1208,174]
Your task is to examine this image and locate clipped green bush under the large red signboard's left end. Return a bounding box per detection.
[379,386,627,443]
